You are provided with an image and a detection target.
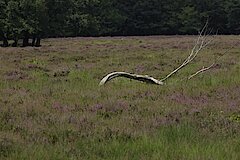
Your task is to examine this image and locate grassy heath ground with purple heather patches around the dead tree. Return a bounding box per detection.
[0,36,240,160]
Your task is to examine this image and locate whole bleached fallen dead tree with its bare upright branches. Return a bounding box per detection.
[99,23,215,86]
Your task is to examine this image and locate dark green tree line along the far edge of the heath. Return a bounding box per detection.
[0,0,240,47]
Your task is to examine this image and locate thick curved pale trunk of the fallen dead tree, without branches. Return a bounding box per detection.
[99,72,164,86]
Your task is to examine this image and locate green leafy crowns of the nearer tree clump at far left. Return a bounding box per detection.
[0,0,48,45]
